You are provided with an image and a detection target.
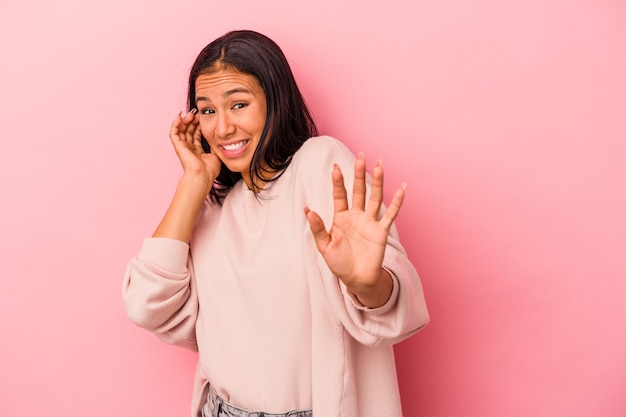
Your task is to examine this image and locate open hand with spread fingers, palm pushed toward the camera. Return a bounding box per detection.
[305,154,405,307]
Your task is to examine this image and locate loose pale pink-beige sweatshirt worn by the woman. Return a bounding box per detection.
[123,137,429,417]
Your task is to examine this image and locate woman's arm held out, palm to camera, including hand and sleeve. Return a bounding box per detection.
[307,140,429,345]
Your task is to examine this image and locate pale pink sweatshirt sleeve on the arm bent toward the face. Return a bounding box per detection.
[122,238,198,351]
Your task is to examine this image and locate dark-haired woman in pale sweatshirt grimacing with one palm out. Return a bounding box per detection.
[123,31,428,417]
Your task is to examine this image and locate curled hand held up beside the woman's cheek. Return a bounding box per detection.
[170,109,222,183]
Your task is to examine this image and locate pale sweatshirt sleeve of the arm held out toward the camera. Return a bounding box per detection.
[304,138,430,346]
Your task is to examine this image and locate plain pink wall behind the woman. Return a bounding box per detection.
[0,0,626,417]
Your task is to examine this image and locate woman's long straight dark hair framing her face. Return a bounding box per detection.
[187,30,317,204]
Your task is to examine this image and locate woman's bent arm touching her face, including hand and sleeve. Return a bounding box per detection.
[123,111,221,349]
